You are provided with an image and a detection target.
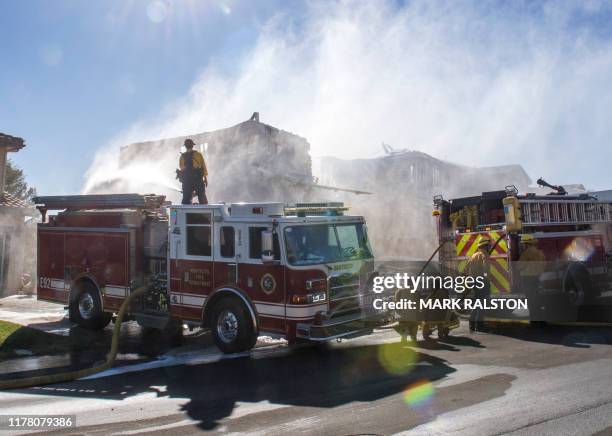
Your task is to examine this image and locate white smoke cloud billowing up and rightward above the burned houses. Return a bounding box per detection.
[85,1,612,191]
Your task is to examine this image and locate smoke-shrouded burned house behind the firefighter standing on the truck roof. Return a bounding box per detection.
[111,112,314,202]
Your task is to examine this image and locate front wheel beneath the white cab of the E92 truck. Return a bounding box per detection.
[210,298,257,353]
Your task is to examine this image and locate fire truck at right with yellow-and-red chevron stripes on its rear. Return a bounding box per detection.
[433,182,612,316]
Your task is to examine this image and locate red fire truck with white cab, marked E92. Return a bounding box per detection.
[35,194,377,352]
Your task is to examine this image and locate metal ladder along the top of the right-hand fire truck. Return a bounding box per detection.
[519,197,612,226]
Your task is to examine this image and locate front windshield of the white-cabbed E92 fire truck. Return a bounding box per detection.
[285,223,372,265]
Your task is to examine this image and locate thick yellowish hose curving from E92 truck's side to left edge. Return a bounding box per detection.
[0,286,147,390]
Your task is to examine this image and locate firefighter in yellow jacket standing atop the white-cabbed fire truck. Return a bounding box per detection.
[177,138,208,204]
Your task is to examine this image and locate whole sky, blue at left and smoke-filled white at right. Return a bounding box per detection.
[0,0,612,194]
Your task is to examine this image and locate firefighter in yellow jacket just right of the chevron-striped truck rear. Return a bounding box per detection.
[519,234,546,322]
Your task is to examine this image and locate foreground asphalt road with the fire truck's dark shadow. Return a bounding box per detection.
[0,326,612,435]
